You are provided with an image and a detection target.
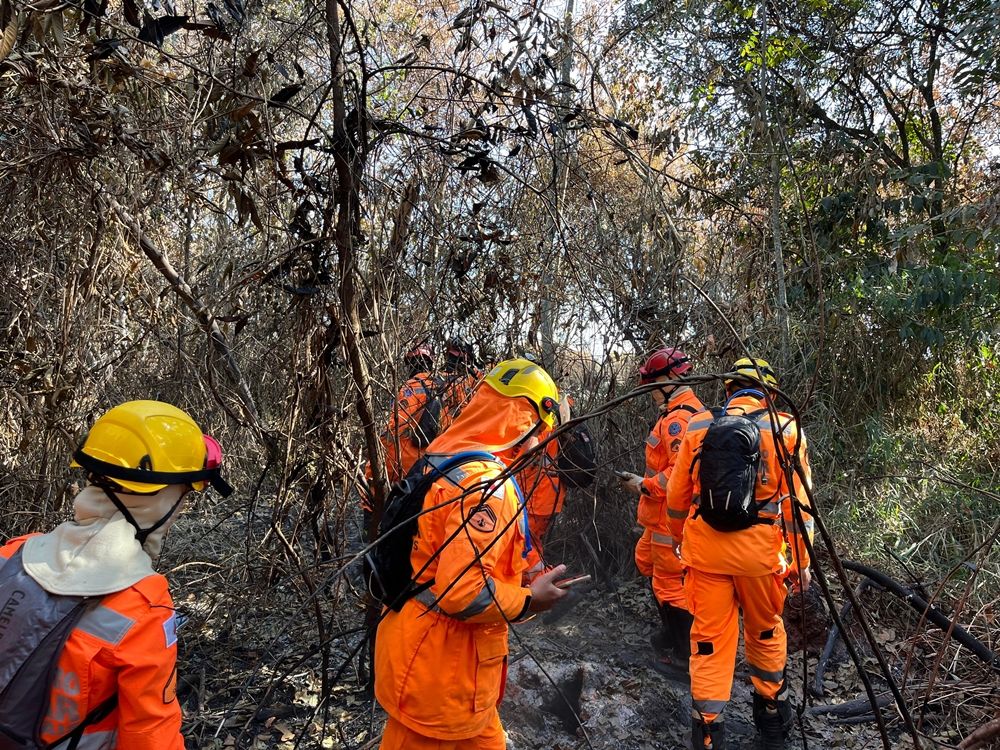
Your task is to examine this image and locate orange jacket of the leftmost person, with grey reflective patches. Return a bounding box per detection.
[0,537,184,750]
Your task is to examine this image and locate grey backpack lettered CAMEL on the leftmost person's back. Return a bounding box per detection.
[0,549,117,750]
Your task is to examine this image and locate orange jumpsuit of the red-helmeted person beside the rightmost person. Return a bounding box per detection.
[635,386,705,609]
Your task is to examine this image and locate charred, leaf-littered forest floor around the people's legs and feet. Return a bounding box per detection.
[164,500,995,750]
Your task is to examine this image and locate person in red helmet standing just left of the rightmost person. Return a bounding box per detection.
[620,348,705,674]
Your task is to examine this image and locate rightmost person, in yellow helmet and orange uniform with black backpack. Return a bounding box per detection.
[667,359,812,750]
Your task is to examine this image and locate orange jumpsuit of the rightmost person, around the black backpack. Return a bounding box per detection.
[667,394,812,721]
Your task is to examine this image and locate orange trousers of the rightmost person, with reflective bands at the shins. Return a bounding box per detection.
[684,568,787,721]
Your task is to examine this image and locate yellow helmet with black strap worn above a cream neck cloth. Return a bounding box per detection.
[70,401,232,495]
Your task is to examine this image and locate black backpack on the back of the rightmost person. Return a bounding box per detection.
[691,408,774,531]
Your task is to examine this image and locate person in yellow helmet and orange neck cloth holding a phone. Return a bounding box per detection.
[375,359,566,750]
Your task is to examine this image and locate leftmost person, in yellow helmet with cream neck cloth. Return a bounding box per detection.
[0,401,231,750]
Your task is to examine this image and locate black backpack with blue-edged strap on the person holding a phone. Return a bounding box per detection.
[364,451,498,612]
